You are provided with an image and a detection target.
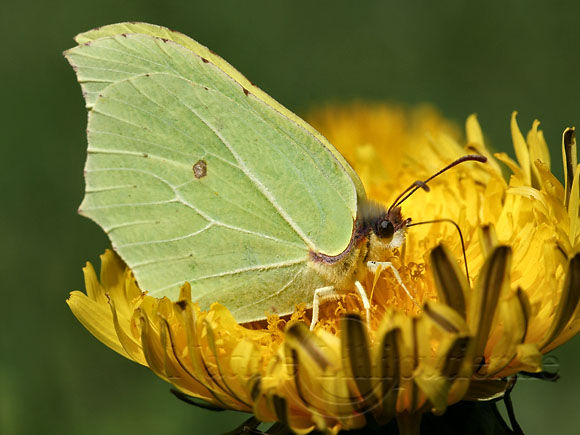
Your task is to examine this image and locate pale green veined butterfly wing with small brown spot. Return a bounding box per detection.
[66,24,356,321]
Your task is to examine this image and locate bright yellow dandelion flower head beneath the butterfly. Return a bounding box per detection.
[68,105,580,433]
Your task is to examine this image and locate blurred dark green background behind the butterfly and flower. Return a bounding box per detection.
[0,0,580,435]
